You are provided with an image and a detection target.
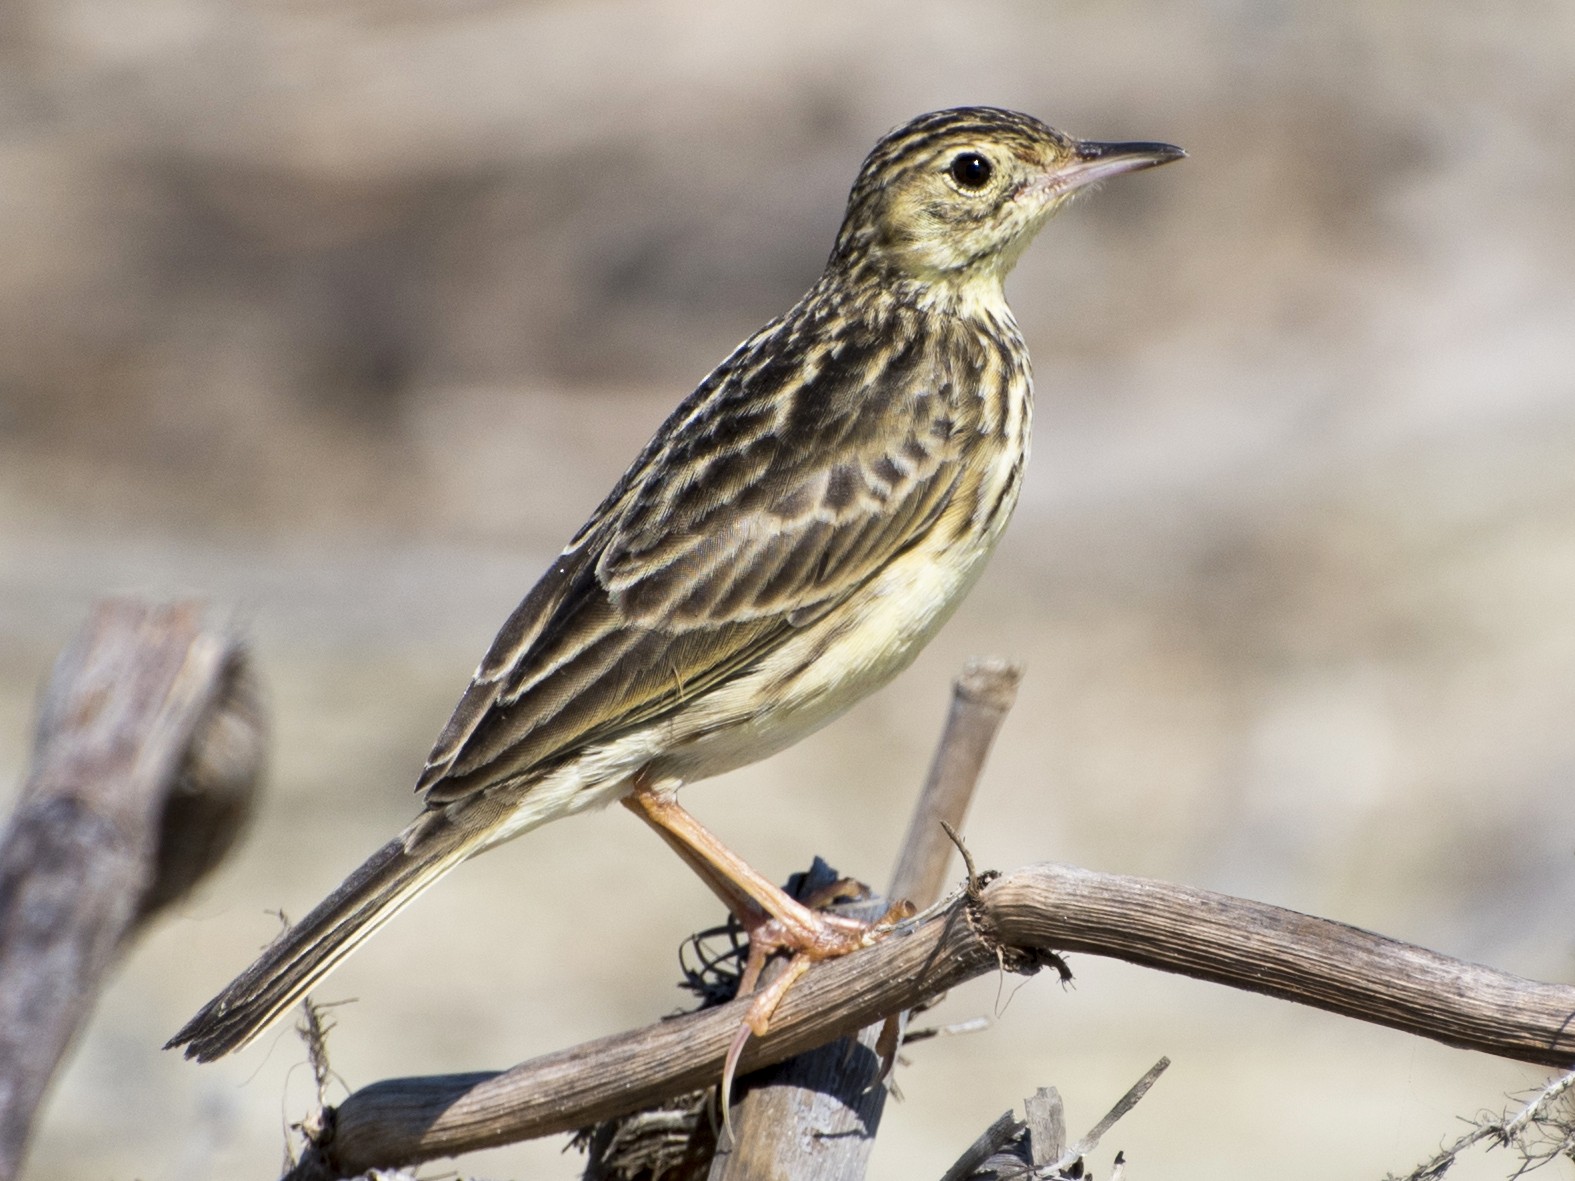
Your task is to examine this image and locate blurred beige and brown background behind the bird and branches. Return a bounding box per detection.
[0,0,1575,1181]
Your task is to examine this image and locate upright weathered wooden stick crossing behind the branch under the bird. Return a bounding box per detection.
[709,660,1022,1181]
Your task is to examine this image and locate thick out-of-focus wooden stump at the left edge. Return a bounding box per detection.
[0,600,261,1179]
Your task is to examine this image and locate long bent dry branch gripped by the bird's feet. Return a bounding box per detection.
[295,864,1575,1178]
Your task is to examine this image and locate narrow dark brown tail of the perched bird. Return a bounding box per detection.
[164,811,487,1061]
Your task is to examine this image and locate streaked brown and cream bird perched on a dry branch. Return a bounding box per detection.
[165,107,1186,1074]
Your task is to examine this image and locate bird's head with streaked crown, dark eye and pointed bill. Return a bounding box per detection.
[832,107,1186,307]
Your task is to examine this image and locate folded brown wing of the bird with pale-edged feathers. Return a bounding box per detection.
[419,314,958,806]
